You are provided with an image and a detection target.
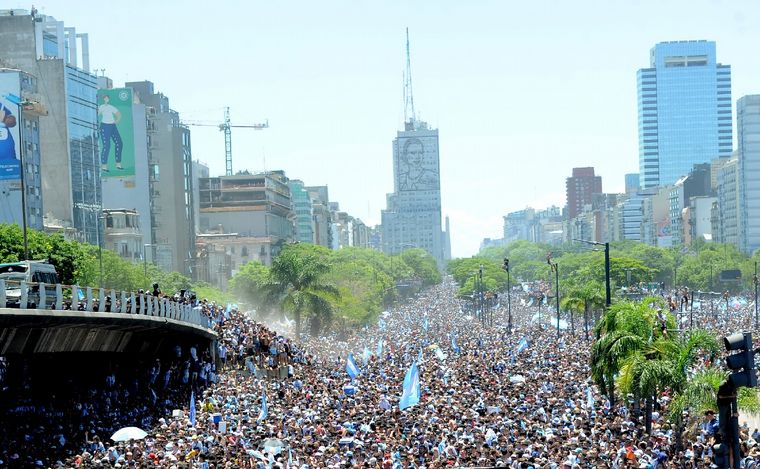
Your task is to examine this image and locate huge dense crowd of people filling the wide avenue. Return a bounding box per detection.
[0,281,760,469]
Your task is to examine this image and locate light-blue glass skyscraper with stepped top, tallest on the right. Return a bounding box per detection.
[637,41,732,189]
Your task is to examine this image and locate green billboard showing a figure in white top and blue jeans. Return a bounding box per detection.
[98,88,135,177]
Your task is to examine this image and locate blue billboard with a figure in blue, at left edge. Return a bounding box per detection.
[0,72,21,180]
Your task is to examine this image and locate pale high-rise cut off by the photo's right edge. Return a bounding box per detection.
[736,95,760,254]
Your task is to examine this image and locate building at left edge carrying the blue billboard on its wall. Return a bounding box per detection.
[0,68,46,230]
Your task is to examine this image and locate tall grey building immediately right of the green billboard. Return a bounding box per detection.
[126,81,195,274]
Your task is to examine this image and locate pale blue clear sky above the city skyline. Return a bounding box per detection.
[16,0,760,257]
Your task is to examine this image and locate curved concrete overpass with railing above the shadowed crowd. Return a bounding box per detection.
[0,281,217,356]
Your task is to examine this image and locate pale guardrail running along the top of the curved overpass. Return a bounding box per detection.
[0,279,211,329]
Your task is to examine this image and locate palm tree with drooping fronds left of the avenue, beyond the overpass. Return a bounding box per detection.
[267,245,339,340]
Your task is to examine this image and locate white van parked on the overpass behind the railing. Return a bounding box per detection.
[0,261,58,309]
